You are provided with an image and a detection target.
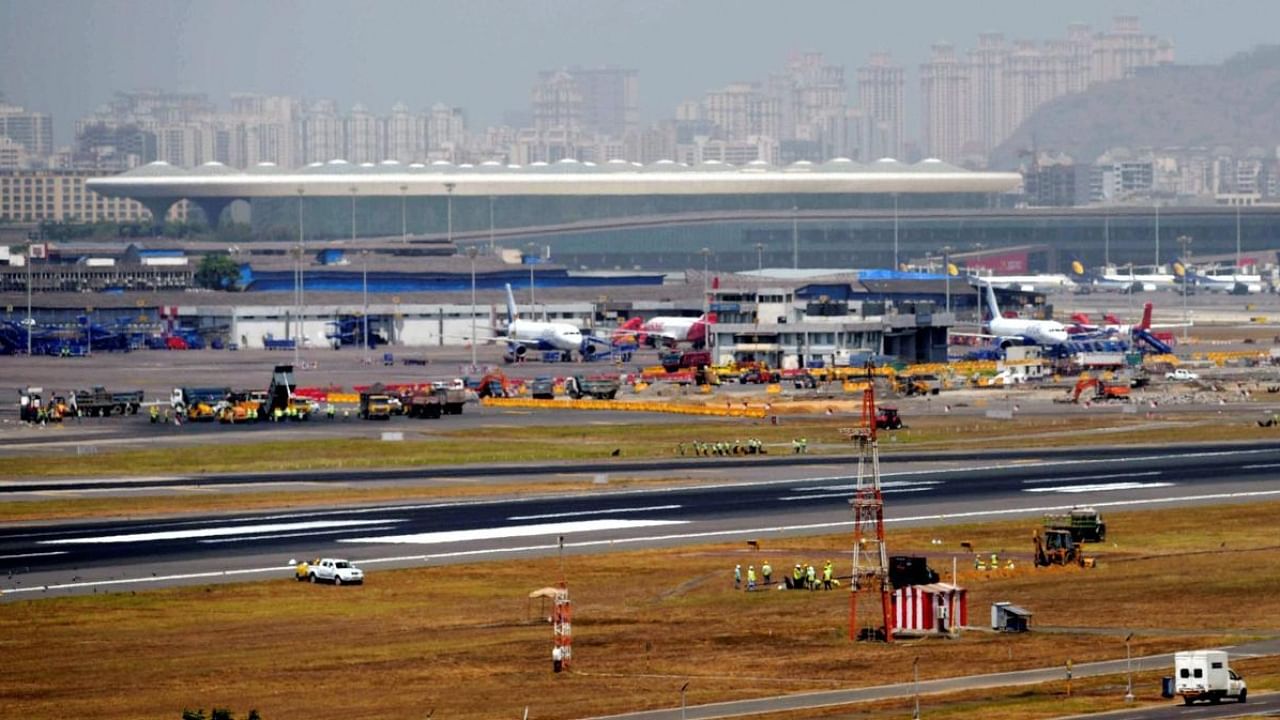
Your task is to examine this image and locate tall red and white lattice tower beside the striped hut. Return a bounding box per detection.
[849,364,893,642]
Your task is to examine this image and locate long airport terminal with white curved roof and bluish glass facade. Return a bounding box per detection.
[87,159,1280,273]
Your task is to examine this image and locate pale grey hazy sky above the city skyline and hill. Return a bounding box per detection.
[0,0,1280,145]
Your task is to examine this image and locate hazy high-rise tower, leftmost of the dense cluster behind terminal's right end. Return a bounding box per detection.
[920,42,973,163]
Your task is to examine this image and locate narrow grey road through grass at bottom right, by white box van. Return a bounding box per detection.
[589,639,1280,720]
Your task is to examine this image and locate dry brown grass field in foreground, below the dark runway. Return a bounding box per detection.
[0,503,1280,720]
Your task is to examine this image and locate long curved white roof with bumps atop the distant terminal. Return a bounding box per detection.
[88,158,1021,199]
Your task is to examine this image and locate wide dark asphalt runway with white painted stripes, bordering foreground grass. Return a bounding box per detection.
[0,445,1280,600]
